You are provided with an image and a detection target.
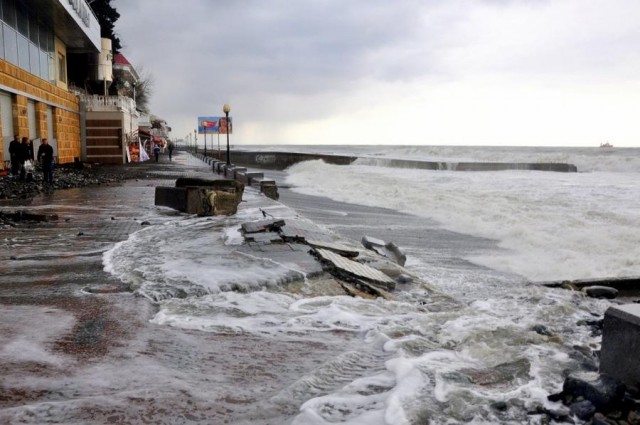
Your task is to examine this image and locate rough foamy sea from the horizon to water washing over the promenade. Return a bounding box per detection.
[103,146,640,425]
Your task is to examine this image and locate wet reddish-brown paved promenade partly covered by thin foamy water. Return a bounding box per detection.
[0,153,383,424]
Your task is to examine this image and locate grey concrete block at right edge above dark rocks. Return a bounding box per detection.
[600,304,640,388]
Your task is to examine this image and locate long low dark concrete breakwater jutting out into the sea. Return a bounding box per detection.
[204,151,578,173]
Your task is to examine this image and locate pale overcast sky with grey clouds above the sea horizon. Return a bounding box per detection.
[112,0,640,146]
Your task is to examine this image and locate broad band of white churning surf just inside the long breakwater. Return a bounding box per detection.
[287,161,640,281]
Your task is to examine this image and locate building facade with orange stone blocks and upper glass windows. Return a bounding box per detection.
[0,0,100,163]
